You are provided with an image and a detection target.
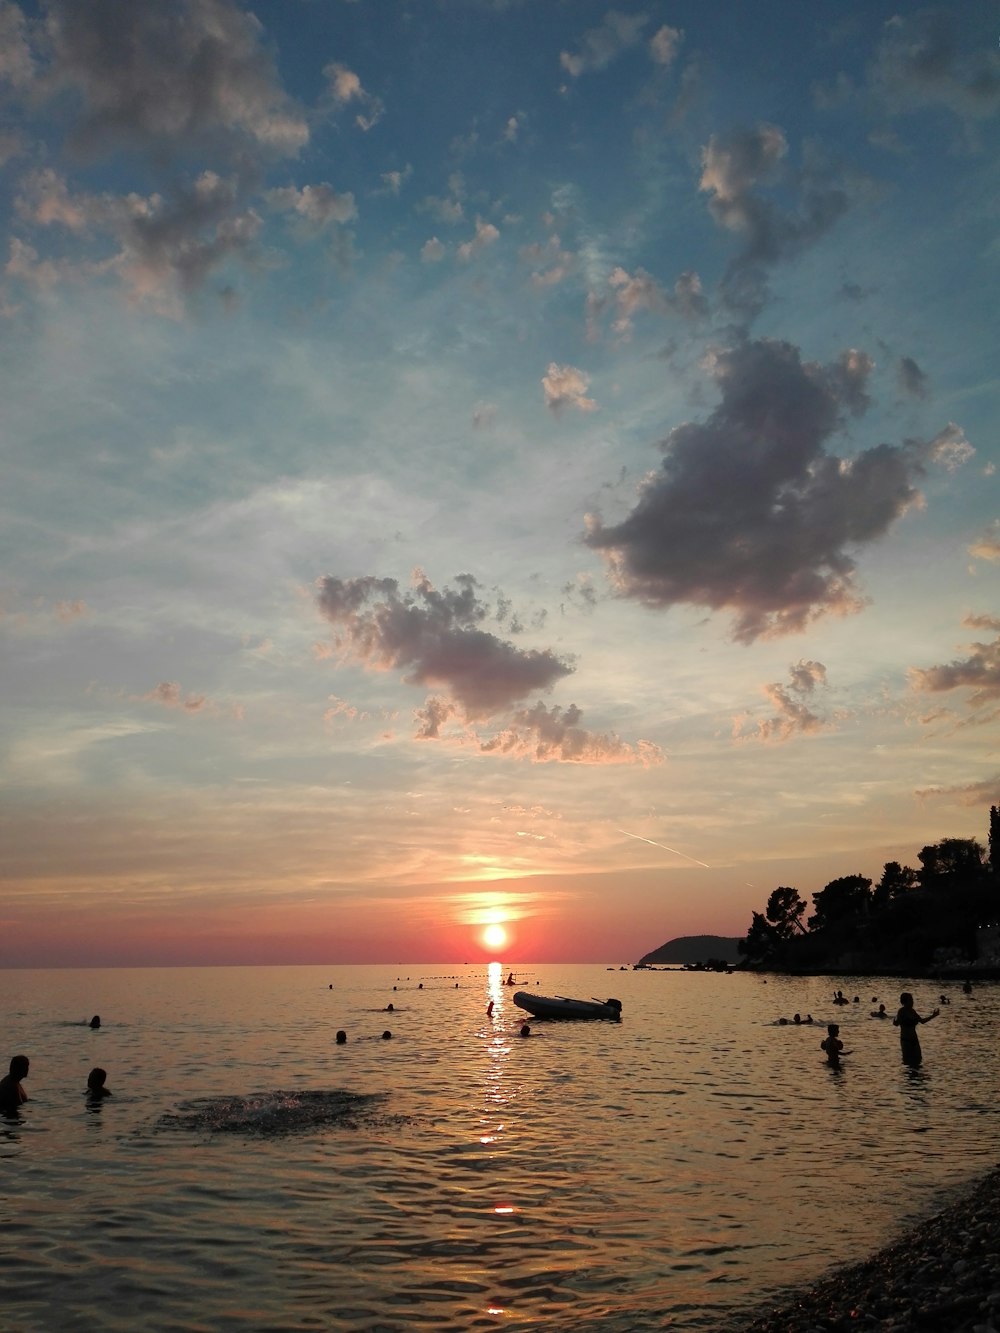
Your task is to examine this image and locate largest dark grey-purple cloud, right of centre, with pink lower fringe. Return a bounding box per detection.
[585,339,933,644]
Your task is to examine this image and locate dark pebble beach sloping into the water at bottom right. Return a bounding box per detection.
[731,1168,1000,1333]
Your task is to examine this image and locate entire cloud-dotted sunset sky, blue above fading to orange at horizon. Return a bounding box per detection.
[0,0,1000,966]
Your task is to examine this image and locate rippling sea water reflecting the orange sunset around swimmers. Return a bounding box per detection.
[0,964,1000,1333]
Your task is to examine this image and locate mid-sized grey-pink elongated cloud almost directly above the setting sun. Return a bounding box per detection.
[317,571,573,718]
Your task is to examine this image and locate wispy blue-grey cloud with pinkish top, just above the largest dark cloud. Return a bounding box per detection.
[700,124,849,317]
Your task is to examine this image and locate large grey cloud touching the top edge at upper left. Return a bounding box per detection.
[43,0,309,155]
